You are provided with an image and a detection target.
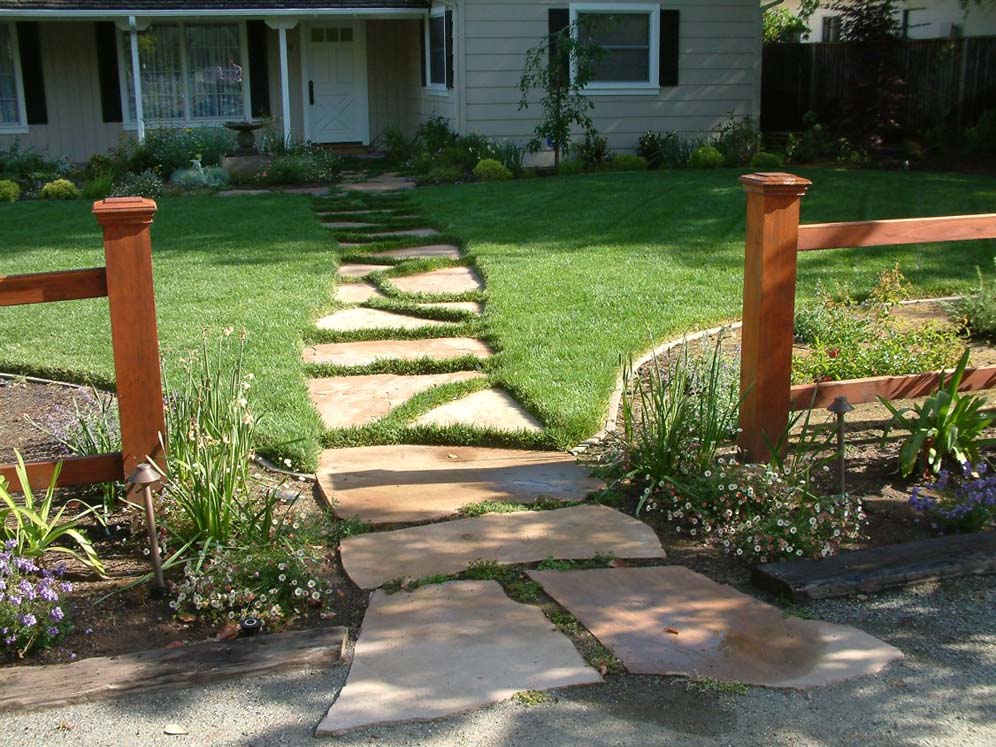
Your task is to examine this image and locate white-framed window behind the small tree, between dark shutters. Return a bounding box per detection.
[571,3,661,91]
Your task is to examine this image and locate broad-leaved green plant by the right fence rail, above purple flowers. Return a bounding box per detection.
[879,349,996,476]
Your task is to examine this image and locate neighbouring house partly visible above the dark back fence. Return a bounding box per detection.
[780,0,996,42]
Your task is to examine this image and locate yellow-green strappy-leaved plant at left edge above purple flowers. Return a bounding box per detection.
[0,452,104,576]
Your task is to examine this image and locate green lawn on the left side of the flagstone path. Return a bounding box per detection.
[0,196,334,465]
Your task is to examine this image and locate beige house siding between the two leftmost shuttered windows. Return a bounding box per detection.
[0,22,123,161]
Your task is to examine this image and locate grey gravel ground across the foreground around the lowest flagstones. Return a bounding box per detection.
[0,577,996,747]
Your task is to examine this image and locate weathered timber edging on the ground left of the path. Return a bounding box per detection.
[0,627,347,713]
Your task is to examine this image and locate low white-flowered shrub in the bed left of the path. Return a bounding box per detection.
[170,541,333,628]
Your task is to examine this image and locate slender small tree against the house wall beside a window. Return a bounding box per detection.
[519,24,602,168]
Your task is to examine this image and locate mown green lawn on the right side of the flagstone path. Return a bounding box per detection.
[412,169,996,446]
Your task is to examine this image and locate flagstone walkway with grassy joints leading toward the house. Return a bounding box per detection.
[304,174,902,735]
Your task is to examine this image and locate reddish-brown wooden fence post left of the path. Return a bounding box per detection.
[93,197,166,479]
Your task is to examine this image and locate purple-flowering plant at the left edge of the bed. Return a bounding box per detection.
[0,540,73,658]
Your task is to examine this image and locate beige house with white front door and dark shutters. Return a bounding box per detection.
[0,0,761,161]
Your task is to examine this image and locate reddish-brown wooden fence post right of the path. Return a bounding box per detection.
[740,174,812,462]
